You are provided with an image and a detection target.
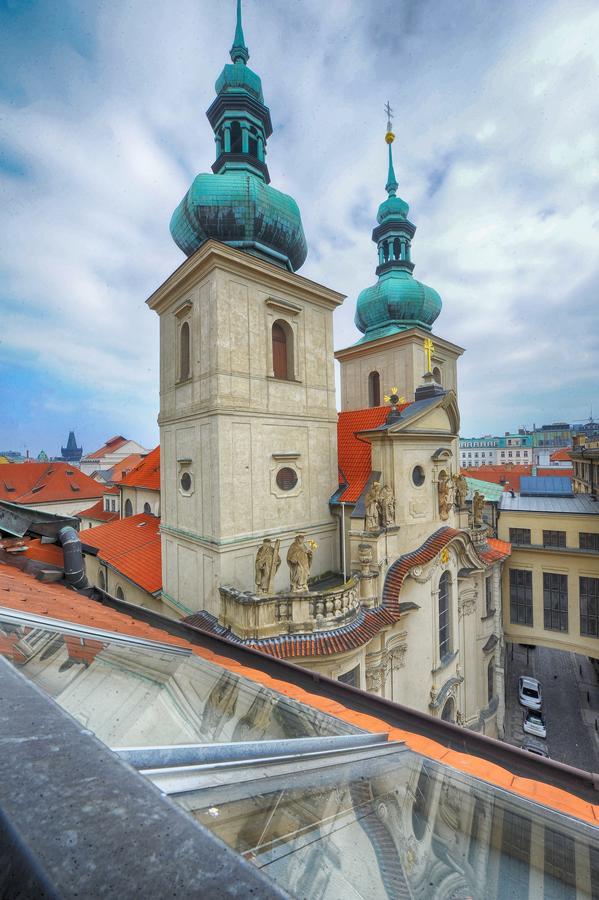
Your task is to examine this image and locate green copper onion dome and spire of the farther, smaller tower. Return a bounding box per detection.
[355,121,442,343]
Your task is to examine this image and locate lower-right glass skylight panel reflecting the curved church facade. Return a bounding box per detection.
[177,744,599,900]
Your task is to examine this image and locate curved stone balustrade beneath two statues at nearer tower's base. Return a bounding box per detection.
[218,578,360,640]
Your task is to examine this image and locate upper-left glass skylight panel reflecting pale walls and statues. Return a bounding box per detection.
[0,614,357,747]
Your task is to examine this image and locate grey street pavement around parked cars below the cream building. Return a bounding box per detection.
[505,644,599,772]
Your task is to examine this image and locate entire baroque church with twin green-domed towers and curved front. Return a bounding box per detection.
[148,0,509,736]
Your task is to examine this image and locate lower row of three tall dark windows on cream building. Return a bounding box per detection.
[510,569,599,637]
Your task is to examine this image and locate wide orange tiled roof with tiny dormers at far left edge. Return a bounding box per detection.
[0,462,104,506]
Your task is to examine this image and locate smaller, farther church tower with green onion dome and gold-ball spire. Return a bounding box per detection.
[335,114,463,410]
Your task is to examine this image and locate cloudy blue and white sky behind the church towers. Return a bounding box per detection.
[0,0,599,454]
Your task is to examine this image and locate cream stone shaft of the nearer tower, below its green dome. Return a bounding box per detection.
[148,241,343,615]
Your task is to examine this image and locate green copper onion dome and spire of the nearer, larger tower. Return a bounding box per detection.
[170,0,308,272]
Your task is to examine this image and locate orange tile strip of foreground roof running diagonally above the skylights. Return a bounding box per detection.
[0,568,599,825]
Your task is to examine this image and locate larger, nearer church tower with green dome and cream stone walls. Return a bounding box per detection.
[148,0,344,615]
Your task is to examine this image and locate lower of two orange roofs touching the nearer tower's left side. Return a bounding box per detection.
[79,513,162,594]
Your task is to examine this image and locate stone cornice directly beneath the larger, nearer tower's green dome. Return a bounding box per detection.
[146,240,345,315]
